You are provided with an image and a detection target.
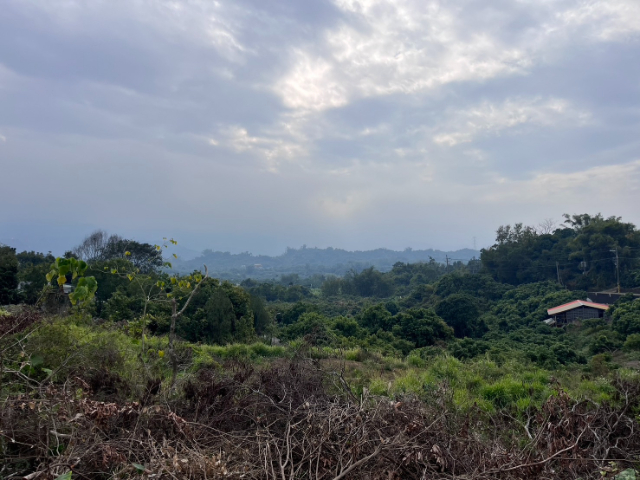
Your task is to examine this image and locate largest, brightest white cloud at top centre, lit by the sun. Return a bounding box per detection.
[275,0,531,110]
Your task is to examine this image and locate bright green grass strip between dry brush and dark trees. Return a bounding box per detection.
[7,317,640,412]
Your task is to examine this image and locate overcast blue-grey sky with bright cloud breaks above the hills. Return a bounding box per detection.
[0,0,640,255]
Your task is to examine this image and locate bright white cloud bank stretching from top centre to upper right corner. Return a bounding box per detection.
[274,0,640,111]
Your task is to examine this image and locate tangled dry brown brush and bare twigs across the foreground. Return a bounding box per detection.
[0,359,640,480]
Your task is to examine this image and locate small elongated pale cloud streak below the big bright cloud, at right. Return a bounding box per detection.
[433,98,591,146]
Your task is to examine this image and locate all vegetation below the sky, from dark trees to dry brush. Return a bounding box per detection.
[0,215,640,479]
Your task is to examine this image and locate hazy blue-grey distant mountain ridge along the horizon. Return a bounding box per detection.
[173,246,480,279]
